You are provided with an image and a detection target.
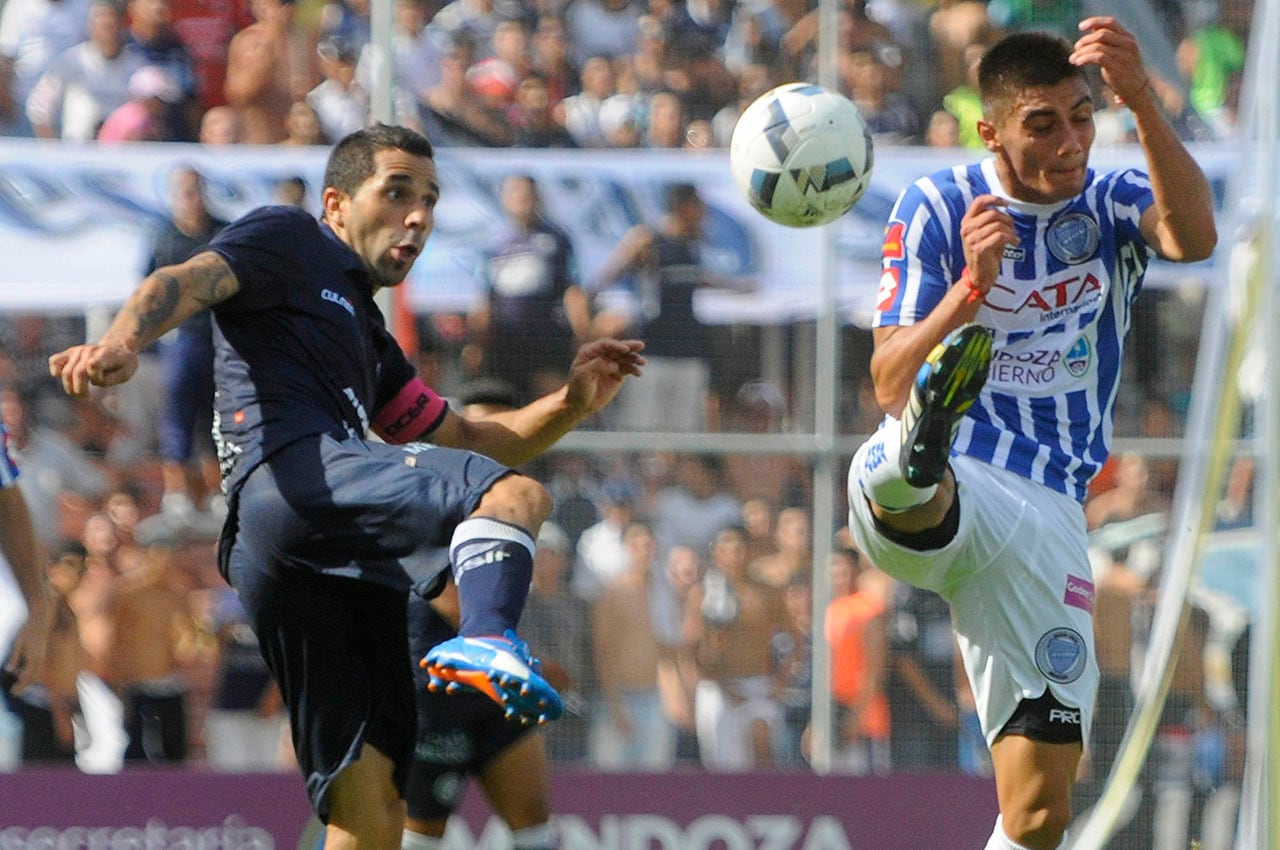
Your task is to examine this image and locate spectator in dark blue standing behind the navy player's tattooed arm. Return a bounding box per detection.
[138,166,227,540]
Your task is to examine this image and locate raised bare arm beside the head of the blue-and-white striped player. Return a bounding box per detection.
[1071,17,1217,262]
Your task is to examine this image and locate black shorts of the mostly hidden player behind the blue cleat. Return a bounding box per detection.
[404,594,536,821]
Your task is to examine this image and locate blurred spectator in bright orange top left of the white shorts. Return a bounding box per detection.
[824,549,891,776]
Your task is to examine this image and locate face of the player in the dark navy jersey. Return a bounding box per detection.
[325,148,440,287]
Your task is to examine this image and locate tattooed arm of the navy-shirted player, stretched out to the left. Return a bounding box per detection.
[49,251,239,397]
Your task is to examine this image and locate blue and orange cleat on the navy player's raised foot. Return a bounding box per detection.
[419,629,564,725]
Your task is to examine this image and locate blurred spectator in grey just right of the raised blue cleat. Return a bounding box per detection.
[520,521,598,762]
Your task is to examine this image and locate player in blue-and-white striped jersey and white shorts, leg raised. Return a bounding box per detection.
[849,17,1217,850]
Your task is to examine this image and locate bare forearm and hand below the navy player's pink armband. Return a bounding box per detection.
[430,339,644,466]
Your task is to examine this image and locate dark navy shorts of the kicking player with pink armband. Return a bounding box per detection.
[219,435,509,821]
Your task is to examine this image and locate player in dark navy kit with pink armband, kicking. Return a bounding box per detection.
[50,124,644,850]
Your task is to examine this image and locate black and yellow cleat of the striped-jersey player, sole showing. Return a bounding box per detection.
[900,324,992,488]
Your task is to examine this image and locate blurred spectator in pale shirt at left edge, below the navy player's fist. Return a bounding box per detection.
[0,387,108,547]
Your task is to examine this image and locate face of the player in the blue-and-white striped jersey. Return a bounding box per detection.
[979,77,1093,204]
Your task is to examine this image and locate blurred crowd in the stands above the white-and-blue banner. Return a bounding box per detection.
[0,0,1252,148]
